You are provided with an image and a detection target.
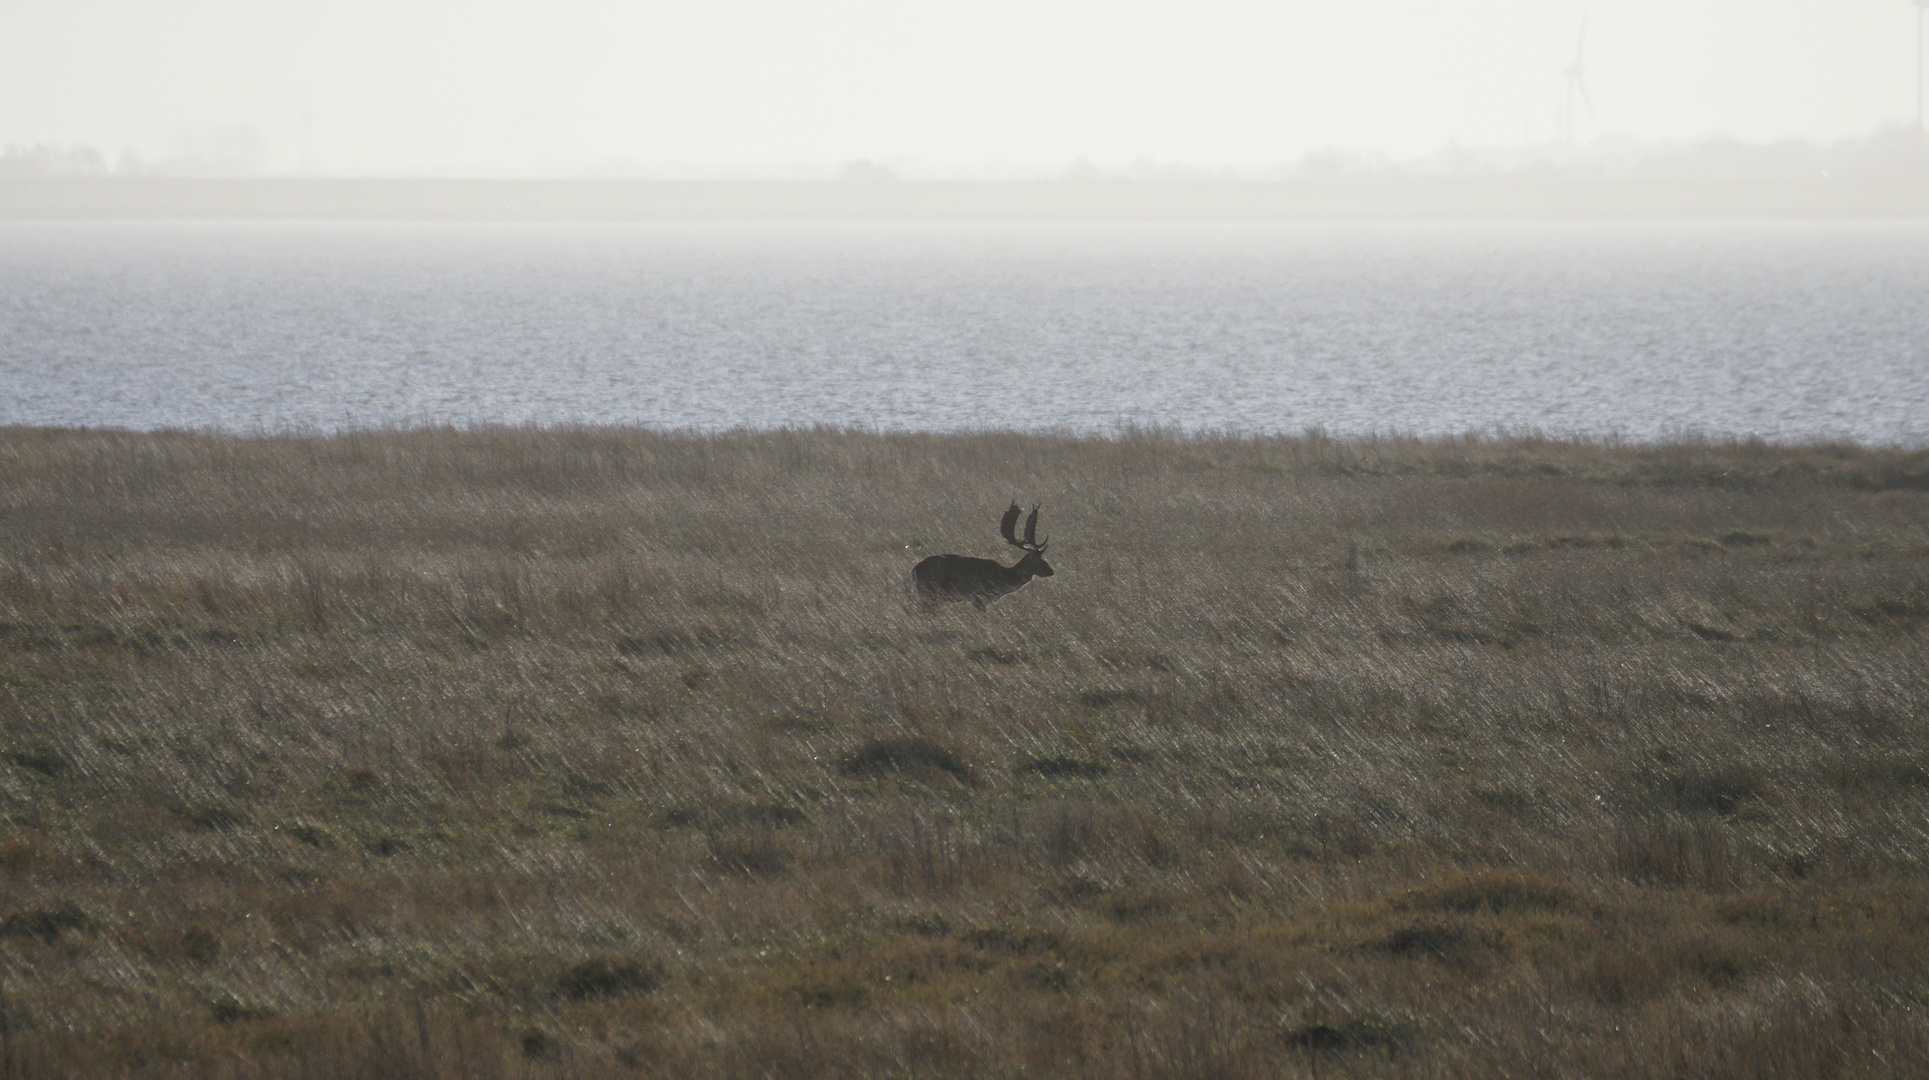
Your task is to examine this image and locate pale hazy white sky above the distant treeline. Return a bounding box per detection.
[0,0,1915,176]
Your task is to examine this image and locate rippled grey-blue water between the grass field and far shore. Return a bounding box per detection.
[0,222,1929,444]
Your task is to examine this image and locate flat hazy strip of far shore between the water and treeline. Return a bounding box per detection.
[0,177,1929,222]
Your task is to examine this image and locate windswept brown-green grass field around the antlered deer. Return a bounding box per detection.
[0,428,1929,1080]
